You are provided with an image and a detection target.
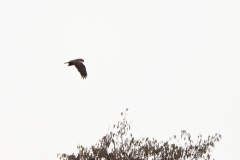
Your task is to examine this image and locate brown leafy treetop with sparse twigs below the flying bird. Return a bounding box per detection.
[58,109,221,160]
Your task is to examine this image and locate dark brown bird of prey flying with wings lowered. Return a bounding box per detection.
[64,59,87,79]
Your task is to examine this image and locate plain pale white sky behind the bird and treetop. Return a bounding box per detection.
[0,0,240,160]
